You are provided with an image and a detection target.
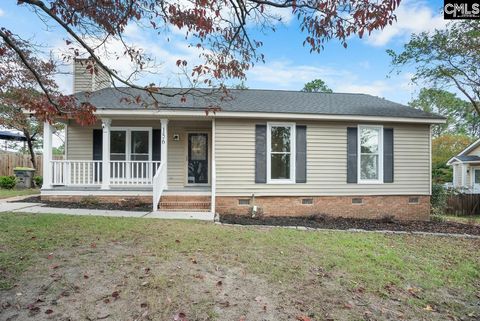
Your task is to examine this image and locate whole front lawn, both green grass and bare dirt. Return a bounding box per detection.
[0,213,480,321]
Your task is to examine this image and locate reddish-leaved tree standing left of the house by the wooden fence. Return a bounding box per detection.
[0,42,69,168]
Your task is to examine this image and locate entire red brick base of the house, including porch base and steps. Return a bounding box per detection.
[41,195,430,220]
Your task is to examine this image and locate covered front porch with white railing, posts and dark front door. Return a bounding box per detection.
[42,117,215,209]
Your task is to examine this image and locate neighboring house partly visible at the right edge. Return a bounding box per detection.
[447,139,480,194]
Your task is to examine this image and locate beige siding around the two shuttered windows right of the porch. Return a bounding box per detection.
[215,119,430,196]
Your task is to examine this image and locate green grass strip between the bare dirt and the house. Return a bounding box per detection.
[0,213,480,292]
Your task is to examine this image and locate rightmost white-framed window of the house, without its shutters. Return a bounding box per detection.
[358,126,383,184]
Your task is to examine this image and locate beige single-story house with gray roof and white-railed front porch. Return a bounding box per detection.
[41,59,444,219]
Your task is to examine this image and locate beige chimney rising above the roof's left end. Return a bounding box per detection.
[73,58,111,94]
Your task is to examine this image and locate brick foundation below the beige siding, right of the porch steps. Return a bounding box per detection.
[216,195,430,220]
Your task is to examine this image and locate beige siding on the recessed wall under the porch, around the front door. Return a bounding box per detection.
[67,120,211,189]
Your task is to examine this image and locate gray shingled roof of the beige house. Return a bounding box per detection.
[73,88,443,119]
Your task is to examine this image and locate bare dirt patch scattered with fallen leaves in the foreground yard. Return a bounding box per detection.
[0,242,475,321]
